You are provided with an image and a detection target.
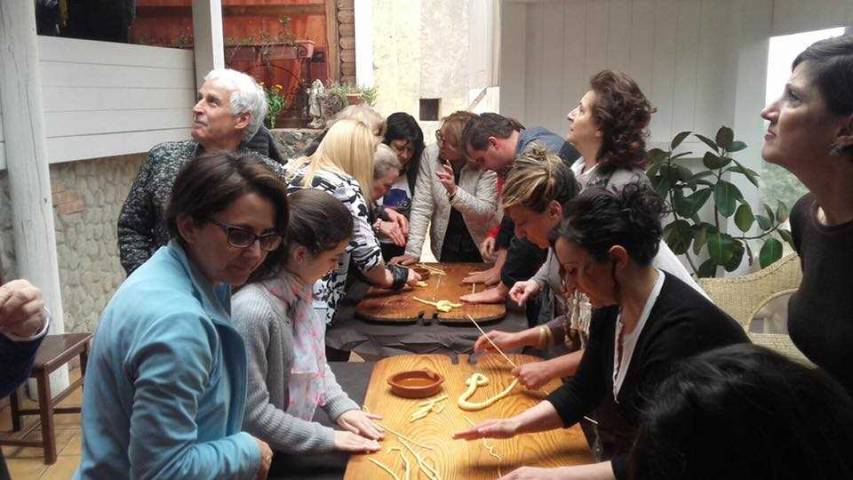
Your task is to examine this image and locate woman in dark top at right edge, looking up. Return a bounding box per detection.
[761,34,853,392]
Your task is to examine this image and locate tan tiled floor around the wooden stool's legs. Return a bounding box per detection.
[0,368,83,480]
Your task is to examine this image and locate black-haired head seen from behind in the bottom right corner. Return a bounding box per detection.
[630,345,853,480]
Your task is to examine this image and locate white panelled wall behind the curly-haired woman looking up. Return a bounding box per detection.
[501,0,738,141]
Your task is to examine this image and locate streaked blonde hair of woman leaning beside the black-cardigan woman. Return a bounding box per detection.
[503,144,580,213]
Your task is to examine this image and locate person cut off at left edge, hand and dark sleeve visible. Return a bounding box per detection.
[0,280,50,480]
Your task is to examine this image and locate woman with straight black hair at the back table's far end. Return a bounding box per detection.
[378,112,429,261]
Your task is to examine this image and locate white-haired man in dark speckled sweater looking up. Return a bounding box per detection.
[118,69,284,275]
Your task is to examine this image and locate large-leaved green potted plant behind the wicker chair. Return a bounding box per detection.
[646,126,792,277]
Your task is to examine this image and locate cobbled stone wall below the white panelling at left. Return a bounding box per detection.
[0,154,145,332]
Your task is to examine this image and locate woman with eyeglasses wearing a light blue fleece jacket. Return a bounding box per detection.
[75,152,288,479]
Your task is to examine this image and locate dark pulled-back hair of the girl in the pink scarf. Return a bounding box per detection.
[284,188,353,255]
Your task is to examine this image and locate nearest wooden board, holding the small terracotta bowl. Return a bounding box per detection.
[344,354,594,480]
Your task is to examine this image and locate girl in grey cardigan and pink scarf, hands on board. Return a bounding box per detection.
[232,189,383,453]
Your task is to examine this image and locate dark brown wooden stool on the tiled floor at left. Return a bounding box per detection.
[0,333,92,465]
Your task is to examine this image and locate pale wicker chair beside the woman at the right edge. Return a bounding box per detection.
[699,254,812,365]
